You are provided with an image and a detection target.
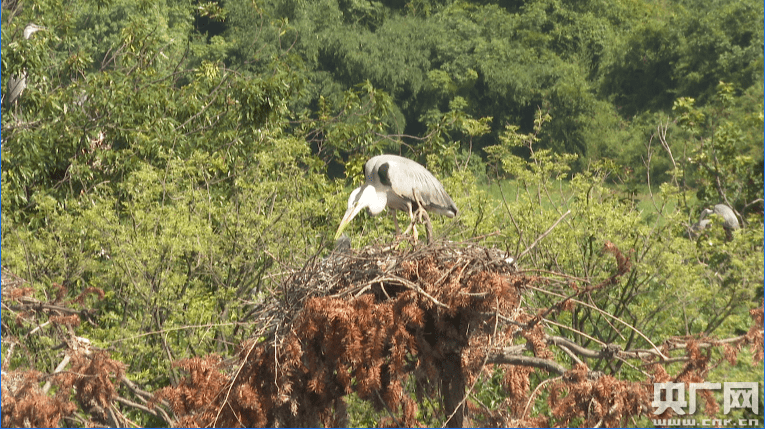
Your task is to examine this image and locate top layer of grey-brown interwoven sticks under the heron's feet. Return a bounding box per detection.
[254,237,520,336]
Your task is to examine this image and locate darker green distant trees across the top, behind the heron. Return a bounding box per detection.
[222,0,762,182]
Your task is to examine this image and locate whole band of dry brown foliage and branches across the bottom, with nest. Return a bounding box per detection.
[2,243,763,427]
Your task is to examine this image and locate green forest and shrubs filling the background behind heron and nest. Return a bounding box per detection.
[1,0,763,425]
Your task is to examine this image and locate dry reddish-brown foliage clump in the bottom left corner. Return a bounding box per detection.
[2,270,131,427]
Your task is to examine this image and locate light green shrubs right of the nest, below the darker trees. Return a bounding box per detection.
[486,109,763,347]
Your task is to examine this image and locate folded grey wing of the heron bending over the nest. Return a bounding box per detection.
[378,158,457,217]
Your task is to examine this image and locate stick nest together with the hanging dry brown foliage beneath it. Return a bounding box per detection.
[160,242,530,426]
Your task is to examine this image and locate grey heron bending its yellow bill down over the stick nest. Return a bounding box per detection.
[335,155,458,240]
